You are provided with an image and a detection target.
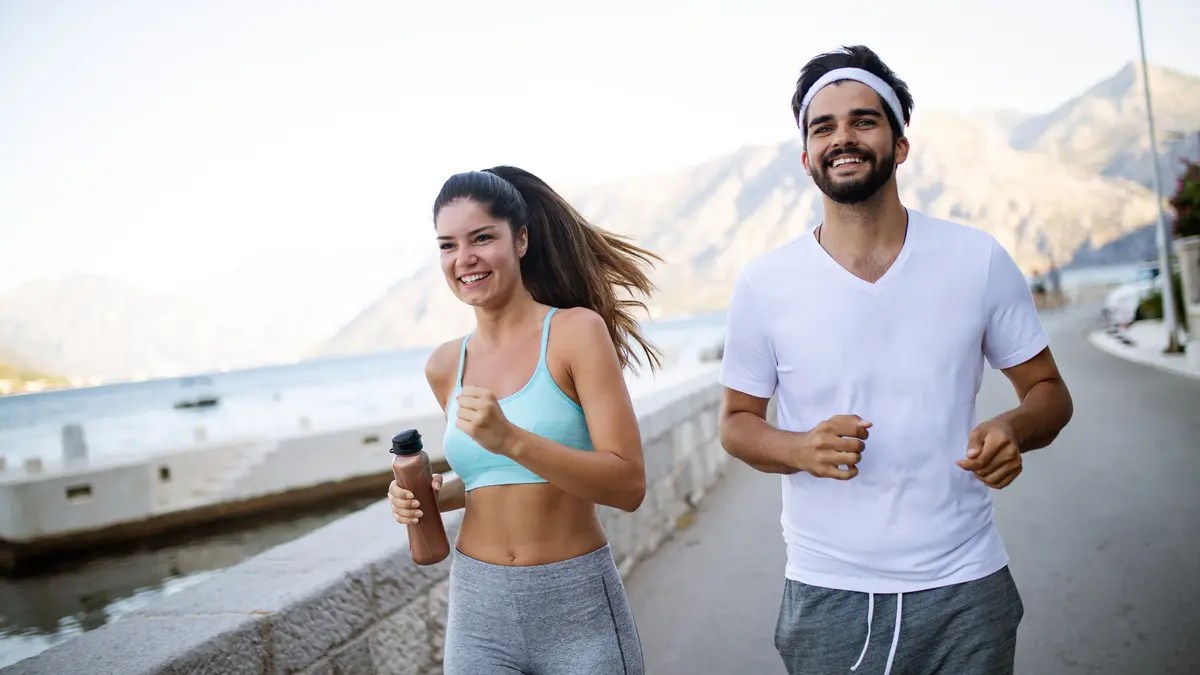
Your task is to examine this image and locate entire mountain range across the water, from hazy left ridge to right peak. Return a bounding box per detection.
[9,60,1200,380]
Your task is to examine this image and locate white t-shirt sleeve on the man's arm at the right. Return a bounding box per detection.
[983,241,1050,370]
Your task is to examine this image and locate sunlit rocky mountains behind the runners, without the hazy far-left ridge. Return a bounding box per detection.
[320,65,1200,354]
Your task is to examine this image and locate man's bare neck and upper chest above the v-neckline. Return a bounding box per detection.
[817,181,908,283]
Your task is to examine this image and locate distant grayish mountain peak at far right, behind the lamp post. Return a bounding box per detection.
[1010,62,1200,189]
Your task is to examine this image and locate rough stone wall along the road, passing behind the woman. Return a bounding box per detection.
[0,366,727,675]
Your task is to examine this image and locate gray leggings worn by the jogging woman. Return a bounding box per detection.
[443,544,643,675]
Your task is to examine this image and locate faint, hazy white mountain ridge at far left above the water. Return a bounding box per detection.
[0,274,355,381]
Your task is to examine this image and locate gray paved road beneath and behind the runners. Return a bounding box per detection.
[628,306,1200,675]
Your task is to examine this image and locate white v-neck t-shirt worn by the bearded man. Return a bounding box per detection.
[720,209,1049,593]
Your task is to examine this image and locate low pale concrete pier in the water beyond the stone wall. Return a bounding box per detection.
[0,414,445,569]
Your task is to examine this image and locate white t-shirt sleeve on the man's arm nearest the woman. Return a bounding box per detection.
[720,270,778,399]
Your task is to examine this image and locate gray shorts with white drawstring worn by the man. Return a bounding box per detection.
[775,567,1025,675]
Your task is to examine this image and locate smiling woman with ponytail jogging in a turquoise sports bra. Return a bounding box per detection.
[389,167,660,675]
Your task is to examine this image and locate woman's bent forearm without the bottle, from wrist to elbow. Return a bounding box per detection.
[504,429,646,513]
